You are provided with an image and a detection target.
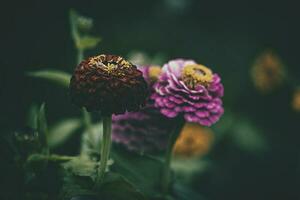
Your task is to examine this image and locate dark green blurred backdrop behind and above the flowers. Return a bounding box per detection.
[0,0,300,200]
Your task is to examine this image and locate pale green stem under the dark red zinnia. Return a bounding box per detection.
[98,116,111,181]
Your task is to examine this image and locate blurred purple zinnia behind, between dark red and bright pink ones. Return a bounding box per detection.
[112,66,171,153]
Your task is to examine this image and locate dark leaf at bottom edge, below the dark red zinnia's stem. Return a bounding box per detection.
[99,173,146,200]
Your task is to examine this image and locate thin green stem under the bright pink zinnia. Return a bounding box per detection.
[161,119,184,195]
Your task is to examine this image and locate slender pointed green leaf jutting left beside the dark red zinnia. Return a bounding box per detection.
[27,69,71,88]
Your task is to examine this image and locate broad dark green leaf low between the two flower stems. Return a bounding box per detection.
[112,148,163,196]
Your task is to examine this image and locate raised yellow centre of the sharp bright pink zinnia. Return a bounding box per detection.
[182,64,213,88]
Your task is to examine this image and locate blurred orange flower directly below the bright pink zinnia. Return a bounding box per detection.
[173,123,214,157]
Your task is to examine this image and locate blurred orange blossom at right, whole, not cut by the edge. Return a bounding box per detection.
[251,50,285,93]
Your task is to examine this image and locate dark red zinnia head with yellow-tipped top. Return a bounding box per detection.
[70,54,148,115]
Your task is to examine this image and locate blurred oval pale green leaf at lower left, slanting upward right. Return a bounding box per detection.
[48,119,82,148]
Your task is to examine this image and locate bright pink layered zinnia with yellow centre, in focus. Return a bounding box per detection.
[151,59,224,126]
